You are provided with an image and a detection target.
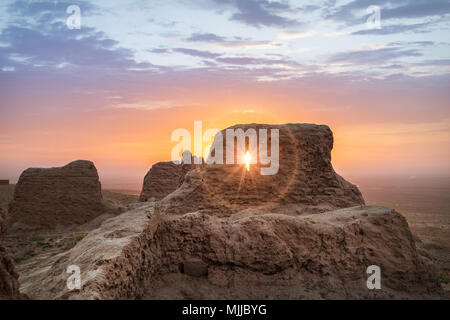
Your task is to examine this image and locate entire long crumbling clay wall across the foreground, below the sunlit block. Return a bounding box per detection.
[29,203,442,299]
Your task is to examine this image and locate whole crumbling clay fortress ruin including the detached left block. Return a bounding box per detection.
[0,124,441,299]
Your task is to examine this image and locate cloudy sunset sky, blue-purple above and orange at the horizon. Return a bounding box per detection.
[0,0,450,185]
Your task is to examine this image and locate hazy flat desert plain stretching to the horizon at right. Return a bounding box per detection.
[350,177,450,290]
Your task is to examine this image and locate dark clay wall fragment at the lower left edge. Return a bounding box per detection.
[0,208,26,300]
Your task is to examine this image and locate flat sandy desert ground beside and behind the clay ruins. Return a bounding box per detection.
[0,184,450,298]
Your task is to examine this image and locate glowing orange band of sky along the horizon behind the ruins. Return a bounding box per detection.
[0,91,450,184]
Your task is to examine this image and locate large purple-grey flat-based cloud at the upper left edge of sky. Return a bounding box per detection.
[0,22,152,68]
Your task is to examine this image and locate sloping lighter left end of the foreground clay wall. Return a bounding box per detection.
[15,202,159,299]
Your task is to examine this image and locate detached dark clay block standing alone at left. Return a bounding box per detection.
[8,160,108,233]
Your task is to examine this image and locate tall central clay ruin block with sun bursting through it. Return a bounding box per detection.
[160,124,364,215]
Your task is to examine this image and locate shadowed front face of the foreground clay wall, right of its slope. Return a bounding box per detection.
[146,206,441,299]
